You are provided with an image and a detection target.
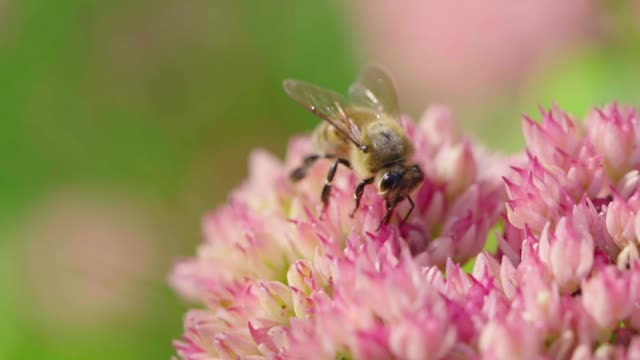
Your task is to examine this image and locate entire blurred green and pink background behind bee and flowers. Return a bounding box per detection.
[0,0,640,359]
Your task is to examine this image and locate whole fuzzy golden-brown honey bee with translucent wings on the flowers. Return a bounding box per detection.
[283,67,424,230]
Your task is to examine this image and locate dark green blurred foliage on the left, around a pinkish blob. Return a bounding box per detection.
[0,0,355,360]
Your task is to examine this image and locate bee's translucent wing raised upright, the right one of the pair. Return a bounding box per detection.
[349,66,399,118]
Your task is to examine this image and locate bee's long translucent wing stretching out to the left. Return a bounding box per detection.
[283,79,367,151]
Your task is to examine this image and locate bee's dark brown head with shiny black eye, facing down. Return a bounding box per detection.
[378,165,424,199]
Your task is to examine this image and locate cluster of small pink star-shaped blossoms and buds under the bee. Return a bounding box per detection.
[170,104,640,360]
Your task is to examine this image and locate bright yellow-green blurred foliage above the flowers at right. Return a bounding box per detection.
[466,42,640,152]
